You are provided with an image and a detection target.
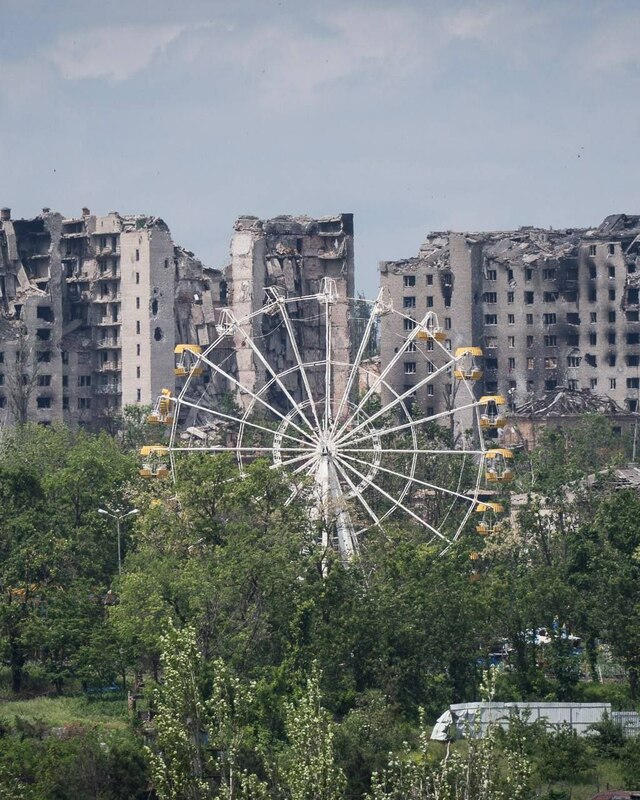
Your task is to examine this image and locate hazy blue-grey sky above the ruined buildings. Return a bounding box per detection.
[0,0,640,295]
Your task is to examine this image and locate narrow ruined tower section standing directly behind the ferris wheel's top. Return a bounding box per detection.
[224,214,354,407]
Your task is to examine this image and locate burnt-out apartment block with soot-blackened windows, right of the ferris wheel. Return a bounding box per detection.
[380,214,640,422]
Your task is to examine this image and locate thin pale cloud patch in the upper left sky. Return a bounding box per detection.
[45,25,185,81]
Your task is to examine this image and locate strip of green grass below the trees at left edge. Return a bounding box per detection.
[0,695,129,731]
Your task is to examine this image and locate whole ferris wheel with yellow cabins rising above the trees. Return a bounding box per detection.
[141,278,512,561]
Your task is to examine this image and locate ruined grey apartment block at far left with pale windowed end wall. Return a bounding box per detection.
[0,208,222,427]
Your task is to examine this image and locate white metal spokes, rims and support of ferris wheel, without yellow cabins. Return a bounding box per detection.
[168,278,488,561]
